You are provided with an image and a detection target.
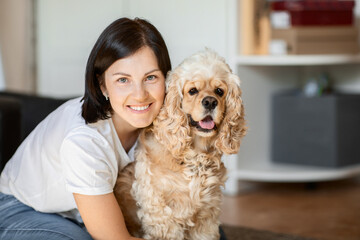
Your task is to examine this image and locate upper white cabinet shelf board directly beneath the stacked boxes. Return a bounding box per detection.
[235,54,360,66]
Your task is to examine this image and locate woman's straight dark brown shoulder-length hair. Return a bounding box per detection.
[82,18,171,123]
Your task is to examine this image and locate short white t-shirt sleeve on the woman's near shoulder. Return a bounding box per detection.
[60,132,118,195]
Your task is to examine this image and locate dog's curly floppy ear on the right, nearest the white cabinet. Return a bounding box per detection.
[215,73,247,154]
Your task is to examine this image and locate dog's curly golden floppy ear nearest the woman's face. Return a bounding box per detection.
[154,72,191,157]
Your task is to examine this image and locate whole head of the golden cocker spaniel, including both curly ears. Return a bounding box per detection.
[154,50,246,158]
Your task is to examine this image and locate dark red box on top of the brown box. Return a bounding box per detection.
[271,0,355,26]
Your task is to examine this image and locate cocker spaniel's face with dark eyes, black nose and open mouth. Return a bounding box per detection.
[182,78,228,137]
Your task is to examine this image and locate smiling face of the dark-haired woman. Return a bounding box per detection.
[102,47,165,130]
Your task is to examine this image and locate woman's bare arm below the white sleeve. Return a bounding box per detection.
[74,193,139,240]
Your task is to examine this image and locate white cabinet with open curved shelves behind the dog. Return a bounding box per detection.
[224,0,360,194]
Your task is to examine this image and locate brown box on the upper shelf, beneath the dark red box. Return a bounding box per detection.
[271,26,359,54]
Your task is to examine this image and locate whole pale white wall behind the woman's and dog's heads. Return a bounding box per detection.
[37,0,227,97]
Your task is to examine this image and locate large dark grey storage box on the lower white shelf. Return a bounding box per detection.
[272,92,360,167]
